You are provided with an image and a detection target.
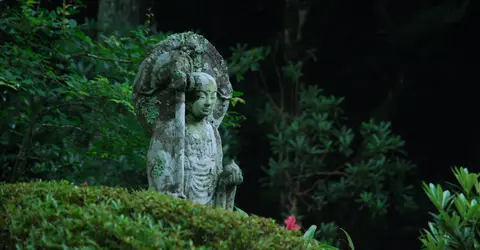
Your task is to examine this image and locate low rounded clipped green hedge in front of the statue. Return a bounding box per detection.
[0,181,334,249]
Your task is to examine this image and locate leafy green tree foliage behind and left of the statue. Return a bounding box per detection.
[0,0,255,187]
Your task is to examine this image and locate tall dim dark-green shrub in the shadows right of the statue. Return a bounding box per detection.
[255,45,416,246]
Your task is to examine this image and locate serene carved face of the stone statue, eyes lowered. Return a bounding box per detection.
[191,80,217,119]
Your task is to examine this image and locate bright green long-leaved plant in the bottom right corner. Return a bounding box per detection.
[420,168,480,250]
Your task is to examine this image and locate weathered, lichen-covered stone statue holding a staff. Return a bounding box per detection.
[133,32,243,209]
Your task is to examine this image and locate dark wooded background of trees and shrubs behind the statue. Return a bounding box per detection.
[0,0,480,249]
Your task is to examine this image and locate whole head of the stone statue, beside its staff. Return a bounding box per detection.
[186,72,217,120]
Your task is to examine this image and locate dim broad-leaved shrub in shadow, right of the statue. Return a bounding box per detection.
[263,84,414,242]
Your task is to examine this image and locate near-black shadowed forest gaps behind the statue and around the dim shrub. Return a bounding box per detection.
[0,0,480,250]
